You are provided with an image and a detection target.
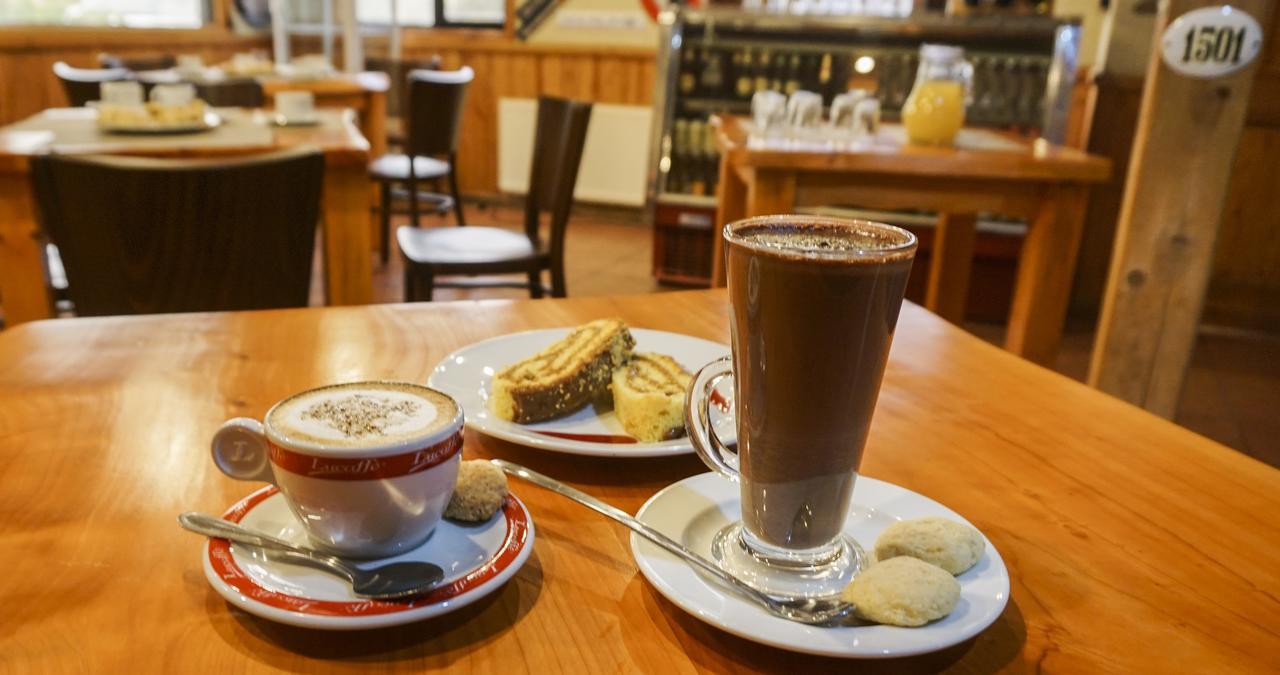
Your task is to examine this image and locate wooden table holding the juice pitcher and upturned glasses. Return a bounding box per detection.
[712,117,1111,365]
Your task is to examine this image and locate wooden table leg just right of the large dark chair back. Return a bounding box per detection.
[324,161,374,305]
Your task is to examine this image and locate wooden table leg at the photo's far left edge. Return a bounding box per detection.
[0,169,54,328]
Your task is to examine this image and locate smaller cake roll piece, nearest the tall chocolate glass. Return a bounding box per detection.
[613,352,692,443]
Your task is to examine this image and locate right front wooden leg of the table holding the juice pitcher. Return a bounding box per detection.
[1005,184,1088,368]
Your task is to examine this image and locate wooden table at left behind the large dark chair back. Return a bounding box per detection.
[0,108,372,327]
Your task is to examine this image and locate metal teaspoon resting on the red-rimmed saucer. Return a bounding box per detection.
[178,511,444,599]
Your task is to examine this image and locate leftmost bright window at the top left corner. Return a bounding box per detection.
[0,0,204,28]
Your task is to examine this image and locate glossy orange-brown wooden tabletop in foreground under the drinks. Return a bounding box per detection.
[0,291,1280,672]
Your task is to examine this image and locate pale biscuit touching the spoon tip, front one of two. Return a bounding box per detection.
[841,556,960,626]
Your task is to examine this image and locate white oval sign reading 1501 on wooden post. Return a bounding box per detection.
[1161,5,1262,78]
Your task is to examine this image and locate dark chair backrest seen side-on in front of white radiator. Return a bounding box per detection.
[525,96,591,257]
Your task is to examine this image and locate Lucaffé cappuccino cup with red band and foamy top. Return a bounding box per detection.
[212,382,462,558]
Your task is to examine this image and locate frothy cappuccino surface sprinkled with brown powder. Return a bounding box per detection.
[266,382,458,448]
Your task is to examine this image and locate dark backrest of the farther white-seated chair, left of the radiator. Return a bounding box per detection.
[404,65,475,156]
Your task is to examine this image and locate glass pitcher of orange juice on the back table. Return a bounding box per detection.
[902,45,973,145]
